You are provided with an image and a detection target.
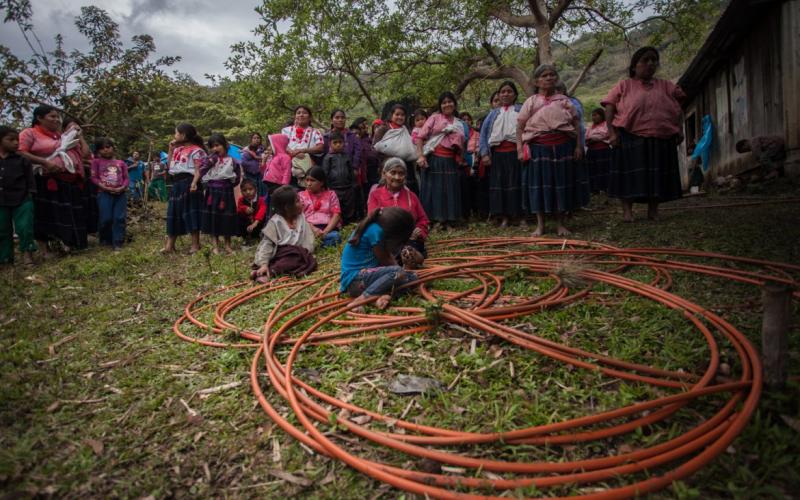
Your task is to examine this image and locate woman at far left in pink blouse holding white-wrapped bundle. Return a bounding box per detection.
[19,104,91,255]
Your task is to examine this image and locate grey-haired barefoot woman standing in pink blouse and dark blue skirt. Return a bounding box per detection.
[517,64,583,237]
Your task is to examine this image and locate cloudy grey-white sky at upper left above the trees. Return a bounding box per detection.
[0,0,259,83]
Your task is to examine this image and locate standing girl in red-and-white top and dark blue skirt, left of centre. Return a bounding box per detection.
[163,123,206,253]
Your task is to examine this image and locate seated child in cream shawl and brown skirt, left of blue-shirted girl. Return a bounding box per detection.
[251,186,317,283]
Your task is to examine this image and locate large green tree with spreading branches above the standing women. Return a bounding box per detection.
[234,0,720,113]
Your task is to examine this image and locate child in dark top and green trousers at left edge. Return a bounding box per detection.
[0,127,36,264]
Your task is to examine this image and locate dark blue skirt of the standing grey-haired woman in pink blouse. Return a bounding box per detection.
[522,139,591,214]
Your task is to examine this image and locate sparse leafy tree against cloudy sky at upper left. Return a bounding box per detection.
[0,0,179,146]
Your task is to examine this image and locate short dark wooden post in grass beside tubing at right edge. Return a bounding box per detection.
[761,282,792,389]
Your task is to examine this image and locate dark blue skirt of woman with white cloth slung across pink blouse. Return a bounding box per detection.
[420,154,463,222]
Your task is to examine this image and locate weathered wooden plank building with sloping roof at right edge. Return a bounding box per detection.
[678,0,800,182]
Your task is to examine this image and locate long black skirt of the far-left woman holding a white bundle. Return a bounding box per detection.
[33,175,87,249]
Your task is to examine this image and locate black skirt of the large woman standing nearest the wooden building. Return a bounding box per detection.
[608,130,683,203]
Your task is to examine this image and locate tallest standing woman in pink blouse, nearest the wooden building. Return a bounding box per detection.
[601,47,686,222]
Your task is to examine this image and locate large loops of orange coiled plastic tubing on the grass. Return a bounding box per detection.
[173,238,800,498]
